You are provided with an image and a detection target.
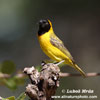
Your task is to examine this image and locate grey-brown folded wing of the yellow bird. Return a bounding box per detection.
[50,34,74,62]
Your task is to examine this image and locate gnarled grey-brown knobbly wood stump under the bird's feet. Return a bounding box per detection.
[24,63,60,100]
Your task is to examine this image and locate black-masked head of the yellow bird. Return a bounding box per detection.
[38,19,51,35]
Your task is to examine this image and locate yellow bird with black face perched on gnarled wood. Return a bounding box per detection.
[38,20,85,77]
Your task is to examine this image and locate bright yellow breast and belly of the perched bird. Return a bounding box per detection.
[39,34,66,62]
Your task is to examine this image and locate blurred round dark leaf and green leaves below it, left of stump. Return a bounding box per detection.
[0,60,26,90]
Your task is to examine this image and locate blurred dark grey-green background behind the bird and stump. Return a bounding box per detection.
[0,0,100,100]
